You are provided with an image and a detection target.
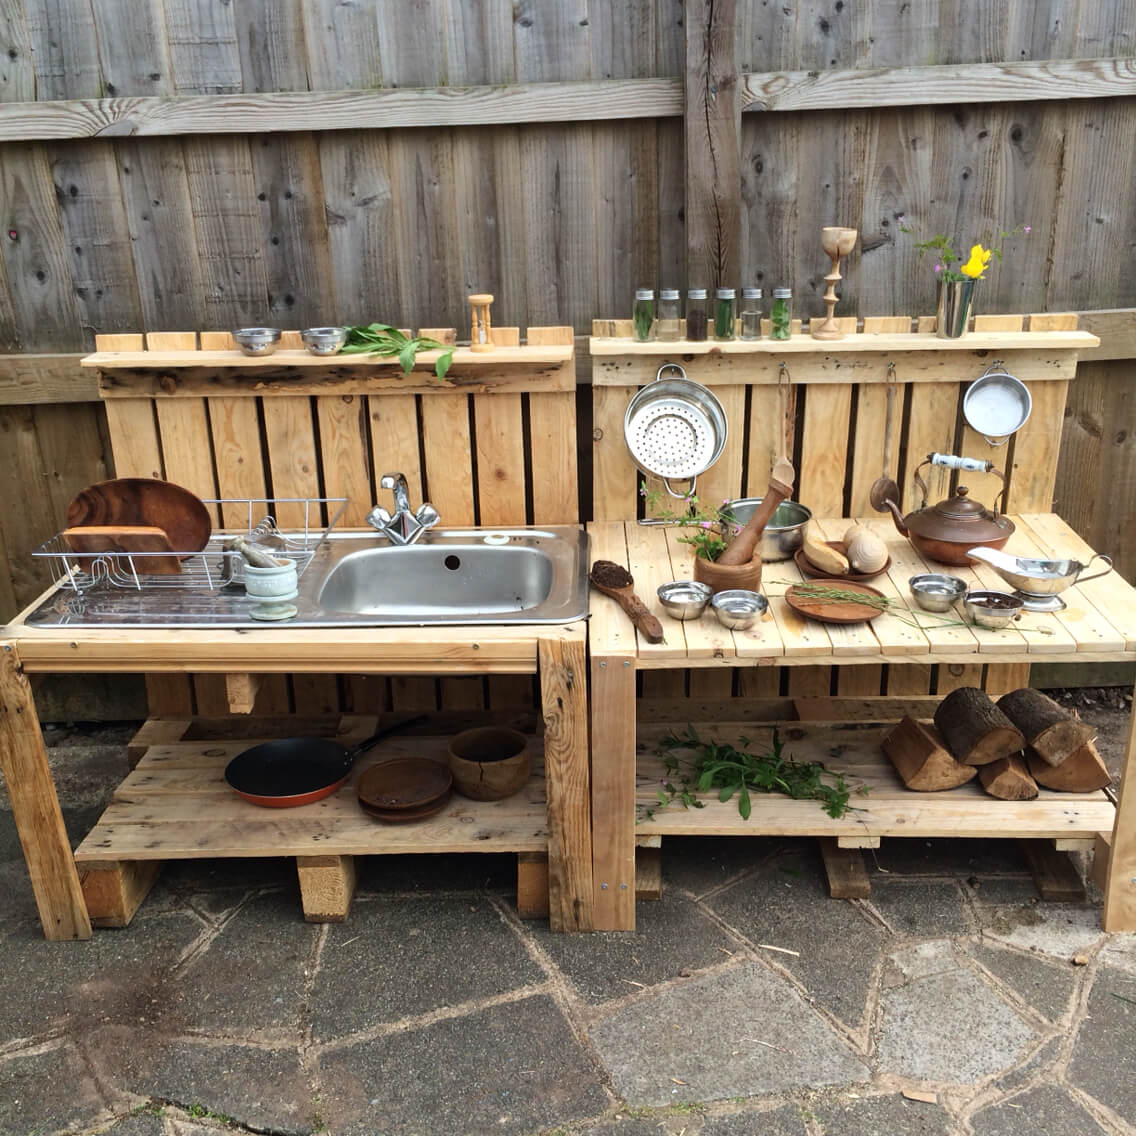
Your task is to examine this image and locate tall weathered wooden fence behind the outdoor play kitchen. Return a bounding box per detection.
[0,0,1136,695]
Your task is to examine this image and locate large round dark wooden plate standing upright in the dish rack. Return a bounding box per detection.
[67,477,212,554]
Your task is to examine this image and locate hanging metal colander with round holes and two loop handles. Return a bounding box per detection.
[624,362,727,499]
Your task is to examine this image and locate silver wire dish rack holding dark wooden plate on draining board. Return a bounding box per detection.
[32,498,348,592]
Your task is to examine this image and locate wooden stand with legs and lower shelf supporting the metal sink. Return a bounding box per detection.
[0,609,593,939]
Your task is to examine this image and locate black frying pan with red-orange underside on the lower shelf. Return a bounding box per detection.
[225,715,426,809]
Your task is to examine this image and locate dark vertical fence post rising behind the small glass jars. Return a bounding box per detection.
[683,0,742,298]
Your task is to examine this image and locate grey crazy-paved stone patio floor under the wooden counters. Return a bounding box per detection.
[0,727,1136,1136]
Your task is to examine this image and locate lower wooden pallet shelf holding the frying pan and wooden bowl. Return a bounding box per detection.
[75,719,548,868]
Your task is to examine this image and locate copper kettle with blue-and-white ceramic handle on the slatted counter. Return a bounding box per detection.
[871,453,1013,567]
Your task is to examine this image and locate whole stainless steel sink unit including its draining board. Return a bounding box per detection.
[27,526,588,629]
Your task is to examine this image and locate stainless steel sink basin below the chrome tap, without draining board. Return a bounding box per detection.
[316,529,587,624]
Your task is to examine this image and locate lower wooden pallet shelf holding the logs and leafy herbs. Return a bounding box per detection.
[635,722,1114,843]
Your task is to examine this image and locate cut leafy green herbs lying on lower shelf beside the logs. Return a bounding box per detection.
[640,726,868,820]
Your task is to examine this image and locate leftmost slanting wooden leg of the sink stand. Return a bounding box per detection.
[0,643,91,939]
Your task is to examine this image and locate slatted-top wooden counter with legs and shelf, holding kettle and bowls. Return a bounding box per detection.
[588,513,1136,930]
